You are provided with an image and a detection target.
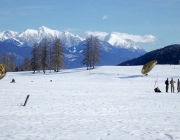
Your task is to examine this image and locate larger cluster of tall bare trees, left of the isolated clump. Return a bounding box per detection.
[30,39,64,73]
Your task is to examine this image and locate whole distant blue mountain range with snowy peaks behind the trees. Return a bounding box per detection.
[0,26,146,68]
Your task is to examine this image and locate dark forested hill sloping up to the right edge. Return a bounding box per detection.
[119,44,180,66]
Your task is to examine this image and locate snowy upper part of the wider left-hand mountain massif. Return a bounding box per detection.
[0,26,83,47]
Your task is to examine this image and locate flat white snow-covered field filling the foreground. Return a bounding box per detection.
[0,65,180,140]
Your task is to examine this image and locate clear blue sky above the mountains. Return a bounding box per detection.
[0,0,180,51]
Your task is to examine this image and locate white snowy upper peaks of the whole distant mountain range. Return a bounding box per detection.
[0,26,142,50]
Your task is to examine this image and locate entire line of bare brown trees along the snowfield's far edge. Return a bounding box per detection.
[0,35,101,74]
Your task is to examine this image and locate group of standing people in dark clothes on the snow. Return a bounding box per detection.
[165,78,180,93]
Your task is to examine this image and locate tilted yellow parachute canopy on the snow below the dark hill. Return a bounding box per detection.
[141,60,157,74]
